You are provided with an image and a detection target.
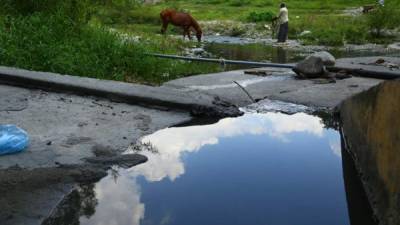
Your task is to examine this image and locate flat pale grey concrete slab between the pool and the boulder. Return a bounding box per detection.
[164,57,393,109]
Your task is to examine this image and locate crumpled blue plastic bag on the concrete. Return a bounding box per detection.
[0,125,29,155]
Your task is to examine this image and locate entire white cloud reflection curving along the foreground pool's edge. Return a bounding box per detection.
[81,113,340,225]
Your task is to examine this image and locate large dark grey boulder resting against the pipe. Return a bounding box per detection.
[293,55,325,78]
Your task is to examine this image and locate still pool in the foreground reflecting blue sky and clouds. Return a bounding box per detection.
[73,113,370,225]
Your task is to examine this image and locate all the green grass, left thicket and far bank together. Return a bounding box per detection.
[0,0,400,85]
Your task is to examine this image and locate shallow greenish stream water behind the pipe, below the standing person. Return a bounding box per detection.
[205,43,400,69]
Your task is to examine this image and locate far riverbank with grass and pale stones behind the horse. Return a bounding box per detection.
[97,0,399,46]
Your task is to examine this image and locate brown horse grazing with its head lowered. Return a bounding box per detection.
[160,9,203,42]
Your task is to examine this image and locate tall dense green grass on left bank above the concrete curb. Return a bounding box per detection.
[0,0,218,84]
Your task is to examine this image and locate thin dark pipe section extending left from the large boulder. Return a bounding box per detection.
[147,54,294,69]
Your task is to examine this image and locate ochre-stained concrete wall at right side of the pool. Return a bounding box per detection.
[341,80,400,225]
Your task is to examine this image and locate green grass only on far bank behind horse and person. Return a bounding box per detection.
[94,0,400,46]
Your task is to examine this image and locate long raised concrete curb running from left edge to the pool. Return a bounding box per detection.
[0,66,240,117]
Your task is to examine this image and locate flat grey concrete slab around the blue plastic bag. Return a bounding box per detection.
[0,85,191,169]
